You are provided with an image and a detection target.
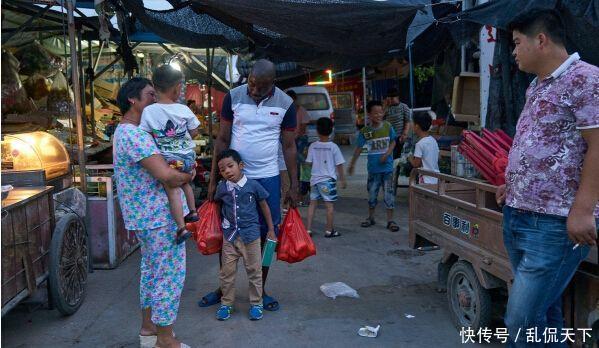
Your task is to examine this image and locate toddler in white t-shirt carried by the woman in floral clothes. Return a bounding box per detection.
[139,65,200,244]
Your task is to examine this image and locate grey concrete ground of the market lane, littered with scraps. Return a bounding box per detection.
[2,147,496,347]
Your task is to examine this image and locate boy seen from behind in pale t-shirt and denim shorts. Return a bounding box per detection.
[306,117,346,238]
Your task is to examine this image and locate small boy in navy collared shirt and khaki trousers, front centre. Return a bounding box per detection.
[214,150,277,321]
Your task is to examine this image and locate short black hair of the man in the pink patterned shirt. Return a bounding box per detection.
[508,10,566,46]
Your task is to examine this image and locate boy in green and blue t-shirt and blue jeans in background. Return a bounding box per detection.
[349,100,399,232]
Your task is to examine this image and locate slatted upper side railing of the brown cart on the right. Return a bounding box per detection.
[410,168,503,219]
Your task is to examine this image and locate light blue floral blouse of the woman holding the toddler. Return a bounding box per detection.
[113,123,189,230]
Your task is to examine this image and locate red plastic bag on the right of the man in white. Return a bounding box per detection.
[277,208,316,263]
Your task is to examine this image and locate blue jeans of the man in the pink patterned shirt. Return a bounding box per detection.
[503,206,599,347]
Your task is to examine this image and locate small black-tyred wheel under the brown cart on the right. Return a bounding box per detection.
[447,261,493,332]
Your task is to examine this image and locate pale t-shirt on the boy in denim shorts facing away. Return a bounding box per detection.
[306,141,345,186]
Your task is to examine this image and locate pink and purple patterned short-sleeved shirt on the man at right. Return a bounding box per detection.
[506,53,599,216]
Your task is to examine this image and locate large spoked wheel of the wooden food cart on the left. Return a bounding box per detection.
[50,213,89,315]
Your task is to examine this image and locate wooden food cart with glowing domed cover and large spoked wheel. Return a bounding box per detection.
[2,131,90,315]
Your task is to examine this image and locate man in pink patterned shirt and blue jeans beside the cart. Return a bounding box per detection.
[497,10,599,347]
